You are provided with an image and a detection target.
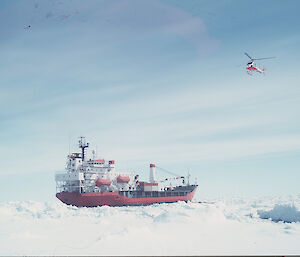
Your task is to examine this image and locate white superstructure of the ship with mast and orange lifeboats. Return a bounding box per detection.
[55,137,137,193]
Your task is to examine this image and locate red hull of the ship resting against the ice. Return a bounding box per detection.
[56,187,197,207]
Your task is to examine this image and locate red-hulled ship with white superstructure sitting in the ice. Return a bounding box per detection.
[55,137,198,207]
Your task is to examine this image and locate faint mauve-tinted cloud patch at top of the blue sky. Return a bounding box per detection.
[101,0,218,55]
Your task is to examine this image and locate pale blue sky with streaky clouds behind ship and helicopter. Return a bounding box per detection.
[0,0,300,201]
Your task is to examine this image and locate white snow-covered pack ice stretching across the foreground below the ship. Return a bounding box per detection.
[0,196,300,255]
